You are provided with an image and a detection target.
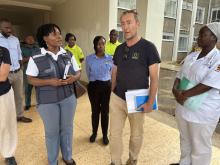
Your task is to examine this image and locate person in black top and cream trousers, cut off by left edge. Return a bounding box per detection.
[0,46,17,165]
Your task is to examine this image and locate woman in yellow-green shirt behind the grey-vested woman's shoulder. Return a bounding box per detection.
[64,33,84,69]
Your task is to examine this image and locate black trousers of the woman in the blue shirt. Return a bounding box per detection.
[88,80,111,136]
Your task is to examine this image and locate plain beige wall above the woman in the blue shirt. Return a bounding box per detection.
[51,0,109,81]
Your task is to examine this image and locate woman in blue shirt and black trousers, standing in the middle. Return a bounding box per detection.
[86,36,113,145]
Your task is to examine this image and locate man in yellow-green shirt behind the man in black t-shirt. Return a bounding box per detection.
[105,29,121,56]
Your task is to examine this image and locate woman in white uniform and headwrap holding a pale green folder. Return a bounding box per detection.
[172,23,220,165]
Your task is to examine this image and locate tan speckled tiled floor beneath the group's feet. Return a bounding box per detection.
[0,95,220,165]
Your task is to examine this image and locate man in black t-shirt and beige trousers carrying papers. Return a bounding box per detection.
[110,10,160,165]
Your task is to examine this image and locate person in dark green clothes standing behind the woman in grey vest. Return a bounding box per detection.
[21,35,39,110]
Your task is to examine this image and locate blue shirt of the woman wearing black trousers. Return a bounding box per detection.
[86,54,113,81]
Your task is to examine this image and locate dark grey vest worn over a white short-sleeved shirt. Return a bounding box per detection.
[32,52,75,104]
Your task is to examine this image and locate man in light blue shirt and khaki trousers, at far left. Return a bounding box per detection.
[0,18,32,123]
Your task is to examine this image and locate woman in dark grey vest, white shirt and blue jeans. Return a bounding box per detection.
[26,24,80,165]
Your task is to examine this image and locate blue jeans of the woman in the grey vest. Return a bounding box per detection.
[37,95,76,165]
